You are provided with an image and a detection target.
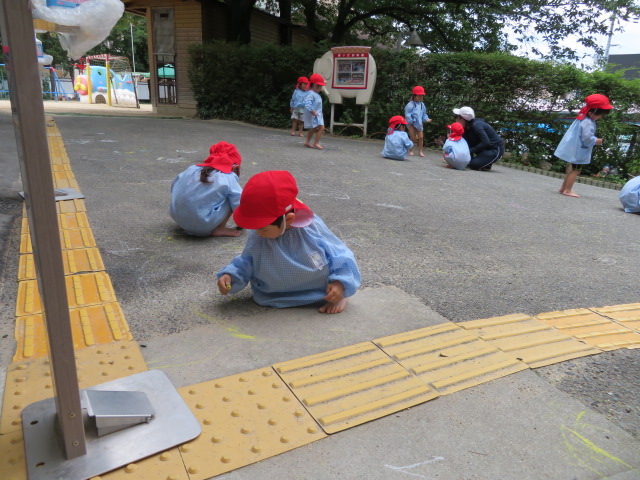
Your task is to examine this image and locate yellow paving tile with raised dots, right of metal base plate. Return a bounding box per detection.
[178,368,326,480]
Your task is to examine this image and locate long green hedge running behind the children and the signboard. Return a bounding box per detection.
[189,42,640,175]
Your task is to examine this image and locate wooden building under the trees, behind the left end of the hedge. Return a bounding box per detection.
[123,0,315,117]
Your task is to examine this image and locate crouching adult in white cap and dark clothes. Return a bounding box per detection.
[453,107,504,170]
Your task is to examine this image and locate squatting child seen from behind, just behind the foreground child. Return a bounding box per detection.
[169,142,242,237]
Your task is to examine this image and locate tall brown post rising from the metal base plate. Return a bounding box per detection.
[0,0,86,459]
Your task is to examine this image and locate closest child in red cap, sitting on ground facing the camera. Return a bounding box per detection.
[216,171,360,313]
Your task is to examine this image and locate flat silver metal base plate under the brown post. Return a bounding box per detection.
[22,370,201,480]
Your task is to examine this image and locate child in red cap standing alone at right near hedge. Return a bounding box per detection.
[553,93,613,198]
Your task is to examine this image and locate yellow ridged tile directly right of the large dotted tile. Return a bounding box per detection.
[274,342,438,433]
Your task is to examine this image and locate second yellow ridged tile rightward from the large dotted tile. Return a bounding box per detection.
[373,323,529,395]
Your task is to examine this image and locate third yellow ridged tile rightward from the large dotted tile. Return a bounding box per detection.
[458,313,602,368]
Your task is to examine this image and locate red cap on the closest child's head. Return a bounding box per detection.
[233,170,313,230]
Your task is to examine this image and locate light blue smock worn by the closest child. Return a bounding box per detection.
[216,215,360,308]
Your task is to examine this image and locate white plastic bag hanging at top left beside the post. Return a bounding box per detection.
[32,0,124,60]
